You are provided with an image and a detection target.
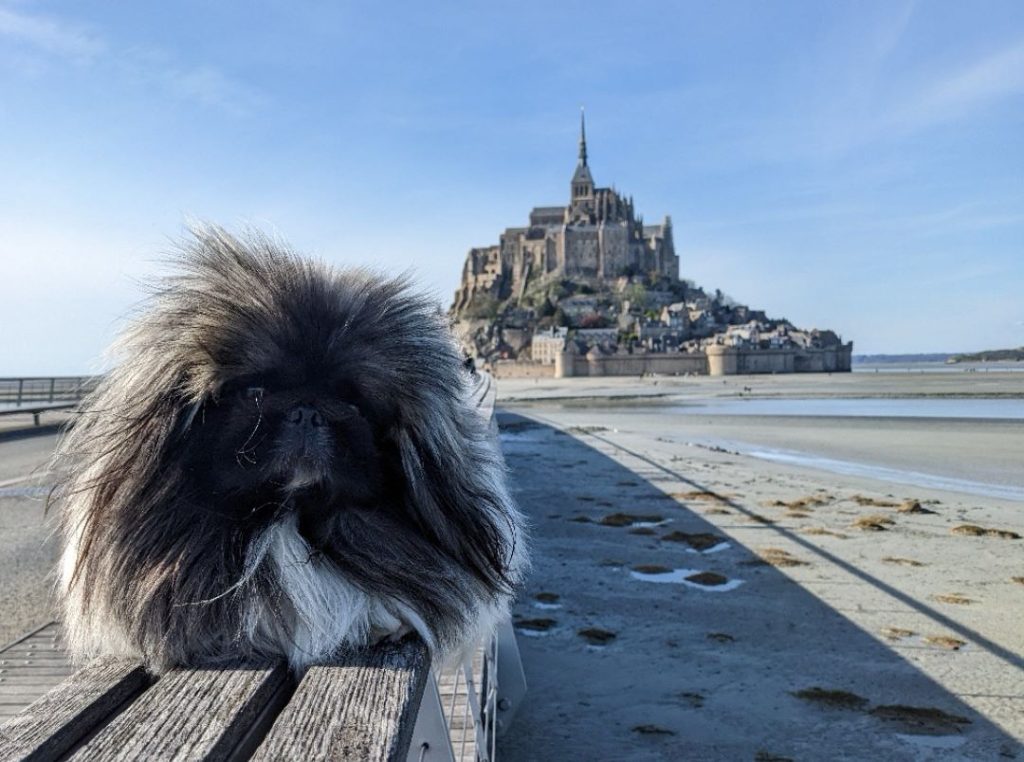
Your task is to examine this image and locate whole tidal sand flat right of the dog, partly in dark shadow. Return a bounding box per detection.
[499,374,1024,760]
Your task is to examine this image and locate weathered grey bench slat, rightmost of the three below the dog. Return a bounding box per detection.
[254,637,430,762]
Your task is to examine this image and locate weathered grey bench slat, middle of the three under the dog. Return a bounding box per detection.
[72,664,289,760]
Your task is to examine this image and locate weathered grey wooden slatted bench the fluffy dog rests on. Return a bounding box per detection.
[0,375,526,762]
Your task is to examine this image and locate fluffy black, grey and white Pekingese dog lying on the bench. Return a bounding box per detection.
[56,227,525,671]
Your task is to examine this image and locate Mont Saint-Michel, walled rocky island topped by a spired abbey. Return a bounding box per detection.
[451,116,853,378]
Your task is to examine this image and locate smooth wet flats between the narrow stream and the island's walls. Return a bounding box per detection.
[499,372,1024,501]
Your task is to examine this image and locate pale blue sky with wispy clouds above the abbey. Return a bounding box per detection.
[0,0,1024,375]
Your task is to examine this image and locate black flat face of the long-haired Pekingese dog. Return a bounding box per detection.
[182,365,400,520]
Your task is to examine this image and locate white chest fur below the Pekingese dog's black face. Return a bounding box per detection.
[245,516,434,668]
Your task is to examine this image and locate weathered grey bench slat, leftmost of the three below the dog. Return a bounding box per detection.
[0,659,150,762]
